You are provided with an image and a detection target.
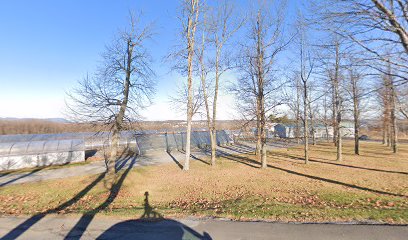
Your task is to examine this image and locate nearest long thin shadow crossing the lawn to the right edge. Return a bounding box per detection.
[226,153,408,198]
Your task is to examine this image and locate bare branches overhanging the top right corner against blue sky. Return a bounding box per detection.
[316,0,408,84]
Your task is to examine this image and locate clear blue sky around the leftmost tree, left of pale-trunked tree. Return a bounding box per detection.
[0,0,296,120]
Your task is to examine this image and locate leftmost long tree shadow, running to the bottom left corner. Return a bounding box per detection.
[1,151,135,240]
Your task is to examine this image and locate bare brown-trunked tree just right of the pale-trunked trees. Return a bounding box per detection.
[234,2,290,168]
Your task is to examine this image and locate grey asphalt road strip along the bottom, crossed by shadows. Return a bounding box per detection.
[0,215,408,240]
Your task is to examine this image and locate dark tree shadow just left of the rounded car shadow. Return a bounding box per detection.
[65,157,136,239]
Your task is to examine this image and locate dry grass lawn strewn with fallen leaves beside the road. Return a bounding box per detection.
[0,141,408,224]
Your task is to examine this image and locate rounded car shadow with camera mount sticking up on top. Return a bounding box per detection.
[97,192,212,240]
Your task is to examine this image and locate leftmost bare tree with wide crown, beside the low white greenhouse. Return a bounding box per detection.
[67,14,155,179]
